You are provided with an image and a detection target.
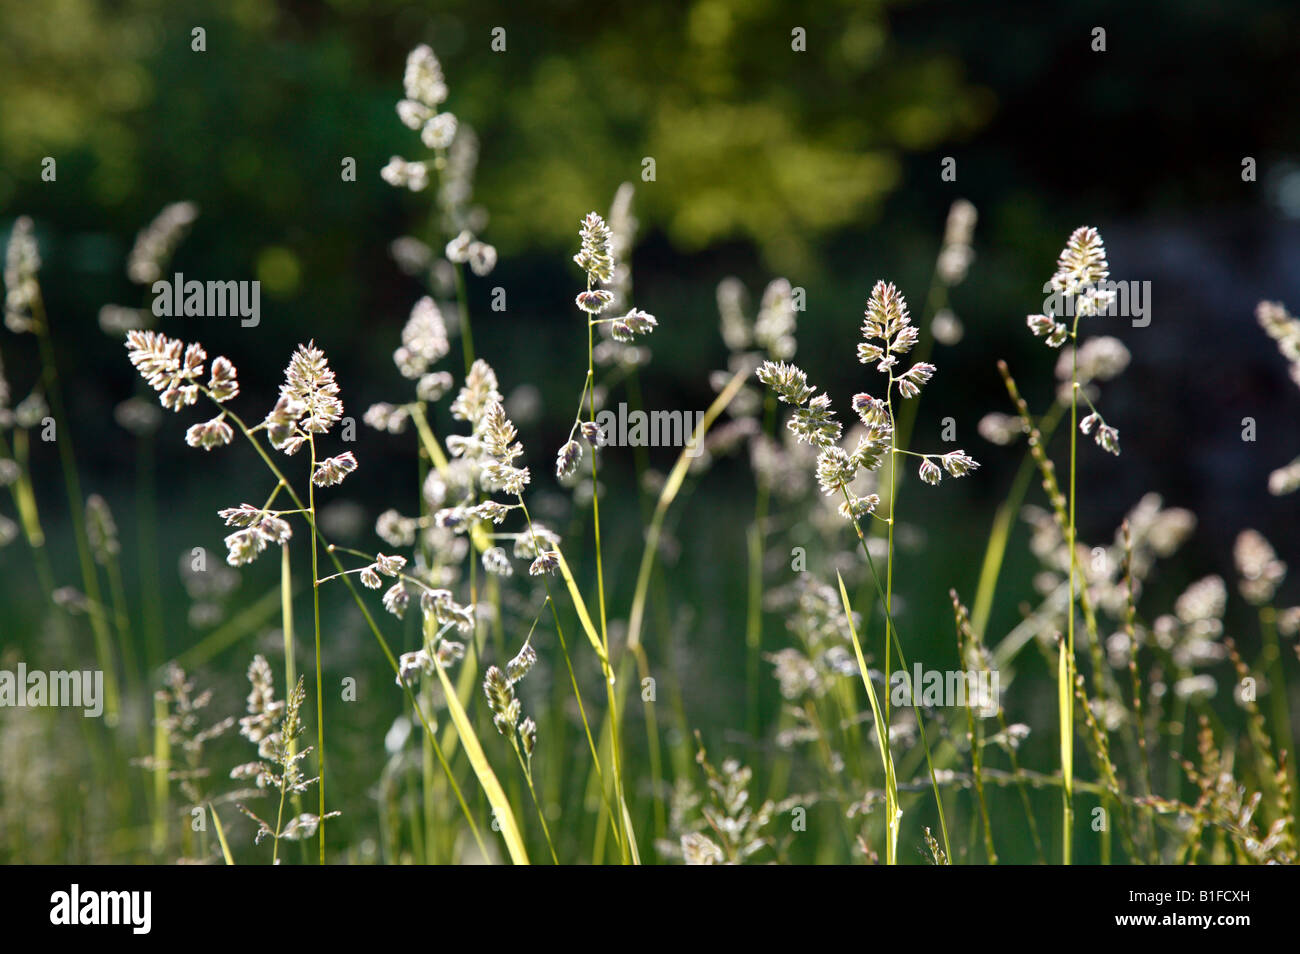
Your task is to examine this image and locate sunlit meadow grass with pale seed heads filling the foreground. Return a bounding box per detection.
[0,47,1300,864]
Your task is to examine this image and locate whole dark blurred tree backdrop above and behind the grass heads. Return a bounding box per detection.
[0,0,1300,540]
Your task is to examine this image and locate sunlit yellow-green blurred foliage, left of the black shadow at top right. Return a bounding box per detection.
[0,0,992,274]
